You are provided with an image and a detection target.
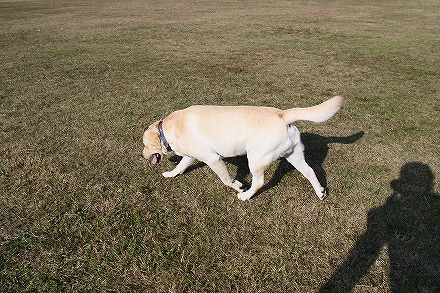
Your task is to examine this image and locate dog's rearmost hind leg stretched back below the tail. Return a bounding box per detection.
[286,144,327,199]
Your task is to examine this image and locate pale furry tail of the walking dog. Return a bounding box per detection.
[281,96,343,124]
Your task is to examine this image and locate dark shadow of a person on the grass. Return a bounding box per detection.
[320,162,440,293]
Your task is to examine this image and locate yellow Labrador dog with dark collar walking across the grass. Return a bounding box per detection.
[142,96,342,200]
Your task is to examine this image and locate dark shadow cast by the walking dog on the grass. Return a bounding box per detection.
[170,131,364,197]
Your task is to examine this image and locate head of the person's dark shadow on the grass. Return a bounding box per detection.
[391,162,434,197]
